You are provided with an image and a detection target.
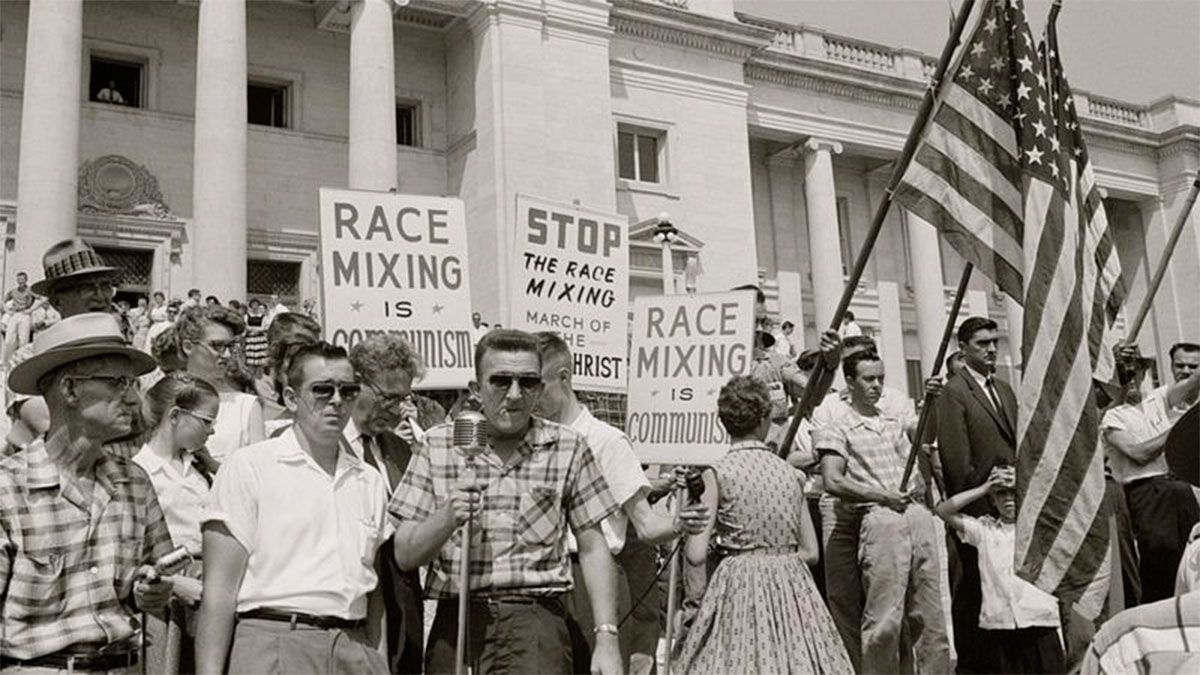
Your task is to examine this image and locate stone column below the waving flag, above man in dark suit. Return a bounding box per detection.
[905,211,952,376]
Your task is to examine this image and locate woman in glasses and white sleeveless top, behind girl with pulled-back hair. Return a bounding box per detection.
[173,306,266,461]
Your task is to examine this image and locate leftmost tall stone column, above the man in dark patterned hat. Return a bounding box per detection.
[7,0,83,281]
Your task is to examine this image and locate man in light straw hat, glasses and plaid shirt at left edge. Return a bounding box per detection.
[0,312,172,673]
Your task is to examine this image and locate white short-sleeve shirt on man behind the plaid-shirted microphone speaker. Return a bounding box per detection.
[571,406,650,555]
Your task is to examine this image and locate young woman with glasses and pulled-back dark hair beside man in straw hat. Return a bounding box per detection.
[133,372,221,673]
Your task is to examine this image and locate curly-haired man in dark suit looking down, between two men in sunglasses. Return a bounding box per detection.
[343,335,425,673]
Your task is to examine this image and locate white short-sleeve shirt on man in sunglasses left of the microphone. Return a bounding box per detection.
[204,428,391,621]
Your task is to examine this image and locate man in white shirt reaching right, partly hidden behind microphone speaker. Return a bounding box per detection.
[535,331,708,673]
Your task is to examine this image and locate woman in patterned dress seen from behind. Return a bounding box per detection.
[674,377,853,674]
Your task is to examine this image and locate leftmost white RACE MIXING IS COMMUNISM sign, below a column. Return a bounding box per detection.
[320,187,474,389]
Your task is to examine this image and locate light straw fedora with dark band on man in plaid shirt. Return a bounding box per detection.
[8,312,157,396]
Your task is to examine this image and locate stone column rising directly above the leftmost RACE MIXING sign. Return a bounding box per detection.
[348,0,397,190]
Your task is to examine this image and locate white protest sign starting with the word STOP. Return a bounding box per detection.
[510,195,629,393]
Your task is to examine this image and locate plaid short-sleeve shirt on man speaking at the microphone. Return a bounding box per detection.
[388,418,618,598]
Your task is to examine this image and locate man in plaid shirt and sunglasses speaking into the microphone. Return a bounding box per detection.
[389,329,622,674]
